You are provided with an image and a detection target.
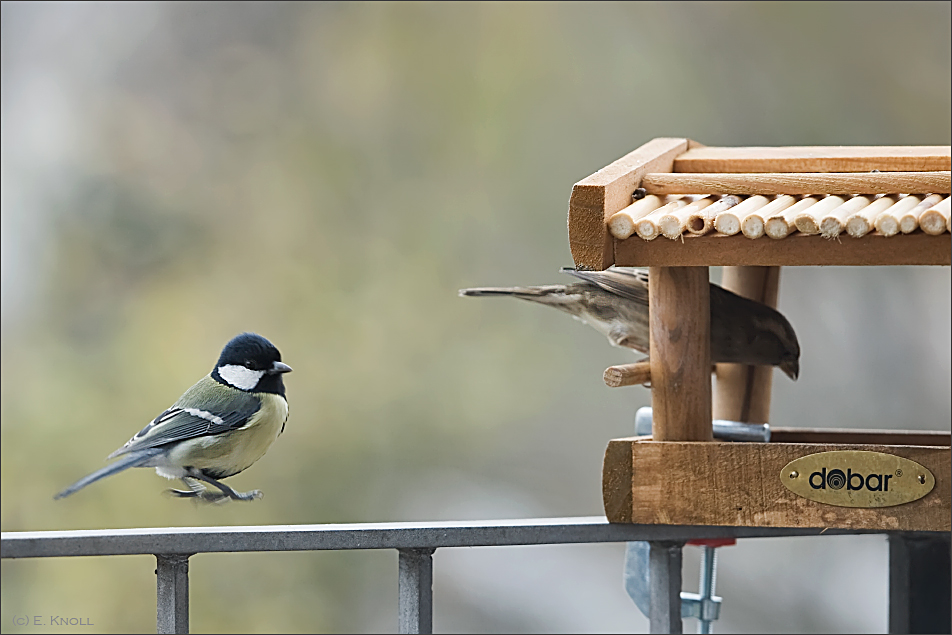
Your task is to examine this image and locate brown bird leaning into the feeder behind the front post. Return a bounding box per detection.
[459,267,800,380]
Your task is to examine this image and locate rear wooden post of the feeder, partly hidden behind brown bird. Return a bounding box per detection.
[714,267,780,423]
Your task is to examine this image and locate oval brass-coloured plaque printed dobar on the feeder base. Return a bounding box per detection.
[780,450,935,507]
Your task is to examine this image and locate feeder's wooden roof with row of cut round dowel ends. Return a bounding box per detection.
[568,138,952,270]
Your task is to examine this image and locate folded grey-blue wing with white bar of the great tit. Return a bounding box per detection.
[109,376,261,458]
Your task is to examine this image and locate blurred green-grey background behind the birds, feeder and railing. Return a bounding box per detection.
[0,2,952,633]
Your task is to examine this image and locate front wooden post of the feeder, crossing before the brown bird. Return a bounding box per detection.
[648,267,714,441]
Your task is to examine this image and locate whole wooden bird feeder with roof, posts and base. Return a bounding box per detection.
[568,138,952,532]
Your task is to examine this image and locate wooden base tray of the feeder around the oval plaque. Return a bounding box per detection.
[602,429,952,531]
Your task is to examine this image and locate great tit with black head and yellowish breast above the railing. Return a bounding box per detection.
[56,333,291,502]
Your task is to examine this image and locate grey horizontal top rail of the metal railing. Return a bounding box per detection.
[0,516,883,558]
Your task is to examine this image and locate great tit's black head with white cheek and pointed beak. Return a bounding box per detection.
[212,333,291,395]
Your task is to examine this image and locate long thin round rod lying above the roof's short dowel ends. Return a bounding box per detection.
[641,172,952,195]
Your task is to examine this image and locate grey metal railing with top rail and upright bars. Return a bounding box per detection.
[0,516,882,633]
